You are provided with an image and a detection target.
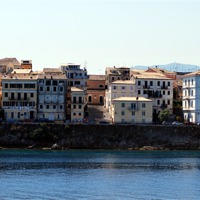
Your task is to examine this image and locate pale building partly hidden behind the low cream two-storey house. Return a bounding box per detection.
[105,80,136,114]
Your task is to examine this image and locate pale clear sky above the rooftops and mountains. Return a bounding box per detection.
[0,0,200,74]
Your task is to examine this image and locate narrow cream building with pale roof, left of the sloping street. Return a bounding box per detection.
[71,87,86,123]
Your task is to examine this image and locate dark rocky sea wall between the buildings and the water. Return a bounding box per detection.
[0,123,200,150]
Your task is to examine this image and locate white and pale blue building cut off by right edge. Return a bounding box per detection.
[182,71,200,123]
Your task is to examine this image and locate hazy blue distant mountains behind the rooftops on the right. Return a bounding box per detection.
[131,63,200,72]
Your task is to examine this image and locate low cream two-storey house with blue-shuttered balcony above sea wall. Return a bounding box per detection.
[112,97,152,124]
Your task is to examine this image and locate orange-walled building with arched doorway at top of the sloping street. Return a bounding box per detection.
[87,75,105,105]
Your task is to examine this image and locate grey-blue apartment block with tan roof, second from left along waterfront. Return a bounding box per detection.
[37,72,67,121]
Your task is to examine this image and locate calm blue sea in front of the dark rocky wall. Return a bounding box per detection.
[0,150,200,200]
